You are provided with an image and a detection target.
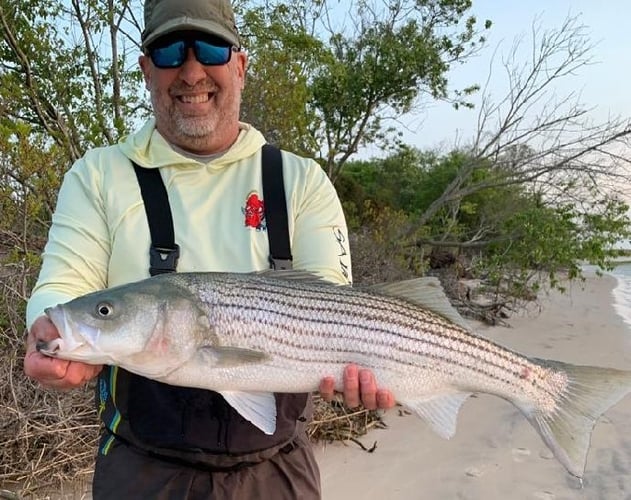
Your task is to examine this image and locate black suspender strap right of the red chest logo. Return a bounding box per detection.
[262,144,292,269]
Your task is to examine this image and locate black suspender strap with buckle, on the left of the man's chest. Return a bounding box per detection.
[132,162,180,276]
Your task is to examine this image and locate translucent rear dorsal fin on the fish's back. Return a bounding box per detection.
[368,276,471,331]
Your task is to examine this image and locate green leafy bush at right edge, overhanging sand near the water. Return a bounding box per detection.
[478,188,631,290]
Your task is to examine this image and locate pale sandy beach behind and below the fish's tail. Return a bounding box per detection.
[316,276,631,500]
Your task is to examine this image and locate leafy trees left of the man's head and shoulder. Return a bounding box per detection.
[0,0,147,262]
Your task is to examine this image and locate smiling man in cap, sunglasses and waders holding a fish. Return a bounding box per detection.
[24,0,394,500]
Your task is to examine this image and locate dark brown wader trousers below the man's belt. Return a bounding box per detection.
[93,428,320,500]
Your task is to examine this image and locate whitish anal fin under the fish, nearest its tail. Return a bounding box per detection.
[401,392,471,439]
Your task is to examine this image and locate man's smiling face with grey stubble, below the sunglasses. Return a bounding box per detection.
[139,32,247,154]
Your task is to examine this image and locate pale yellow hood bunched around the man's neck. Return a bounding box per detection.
[119,118,266,172]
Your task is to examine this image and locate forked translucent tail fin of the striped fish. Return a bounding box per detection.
[518,360,631,478]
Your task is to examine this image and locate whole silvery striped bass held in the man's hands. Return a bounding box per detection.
[38,271,631,478]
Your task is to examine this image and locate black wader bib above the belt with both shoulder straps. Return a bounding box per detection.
[96,145,312,471]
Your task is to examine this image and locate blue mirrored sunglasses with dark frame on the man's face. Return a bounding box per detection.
[149,38,239,69]
